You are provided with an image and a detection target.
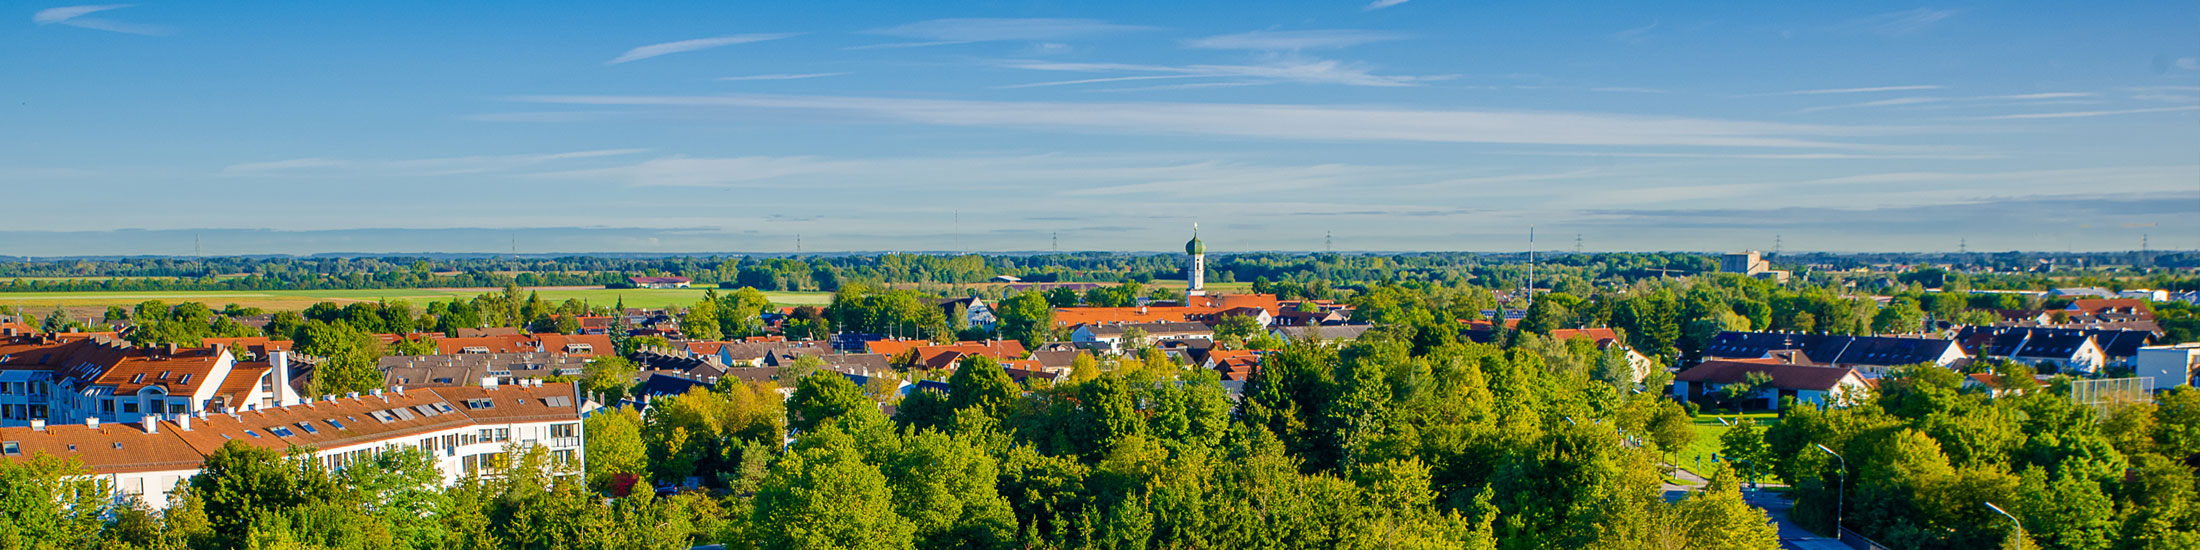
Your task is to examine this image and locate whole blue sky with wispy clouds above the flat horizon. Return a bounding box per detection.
[0,0,2200,255]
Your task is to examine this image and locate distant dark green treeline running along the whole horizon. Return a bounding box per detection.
[17,253,2200,293]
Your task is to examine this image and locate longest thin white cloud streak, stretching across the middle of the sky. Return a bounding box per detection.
[513,95,1916,150]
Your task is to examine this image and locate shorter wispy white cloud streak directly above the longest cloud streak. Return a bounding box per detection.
[1005,59,1452,88]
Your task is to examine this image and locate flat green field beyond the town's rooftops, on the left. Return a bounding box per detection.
[0,286,832,317]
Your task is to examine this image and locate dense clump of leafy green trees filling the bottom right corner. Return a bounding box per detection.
[1727,367,2200,550]
